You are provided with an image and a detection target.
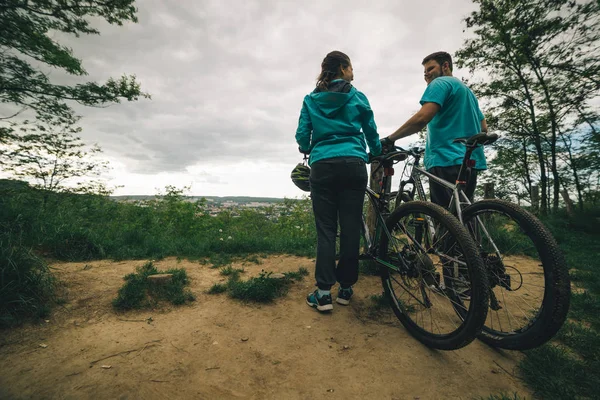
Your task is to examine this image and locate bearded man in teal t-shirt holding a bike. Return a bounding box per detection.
[382,52,487,207]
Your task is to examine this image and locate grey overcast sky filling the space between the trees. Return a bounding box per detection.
[4,0,482,197]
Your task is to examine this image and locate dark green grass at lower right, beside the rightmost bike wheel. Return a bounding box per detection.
[519,211,600,400]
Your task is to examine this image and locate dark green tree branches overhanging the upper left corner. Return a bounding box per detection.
[0,0,149,123]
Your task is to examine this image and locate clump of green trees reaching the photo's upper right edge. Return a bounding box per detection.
[456,0,600,214]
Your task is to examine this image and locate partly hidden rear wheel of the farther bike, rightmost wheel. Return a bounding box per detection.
[463,200,570,349]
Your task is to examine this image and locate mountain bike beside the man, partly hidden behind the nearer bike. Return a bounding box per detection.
[395,133,571,350]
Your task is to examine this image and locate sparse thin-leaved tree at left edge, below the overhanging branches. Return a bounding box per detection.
[0,117,108,194]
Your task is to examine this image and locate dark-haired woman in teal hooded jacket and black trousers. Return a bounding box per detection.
[296,51,381,311]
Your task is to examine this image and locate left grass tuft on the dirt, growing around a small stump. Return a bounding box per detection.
[113,261,195,311]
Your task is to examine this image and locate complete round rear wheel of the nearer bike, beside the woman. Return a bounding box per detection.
[378,201,489,350]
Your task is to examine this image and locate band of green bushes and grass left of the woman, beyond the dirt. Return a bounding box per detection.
[0,180,316,260]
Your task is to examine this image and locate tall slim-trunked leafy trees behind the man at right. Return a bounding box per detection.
[457,0,600,214]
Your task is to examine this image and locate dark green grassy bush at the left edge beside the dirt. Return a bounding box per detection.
[0,231,55,327]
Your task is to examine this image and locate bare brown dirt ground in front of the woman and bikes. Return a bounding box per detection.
[0,255,531,400]
